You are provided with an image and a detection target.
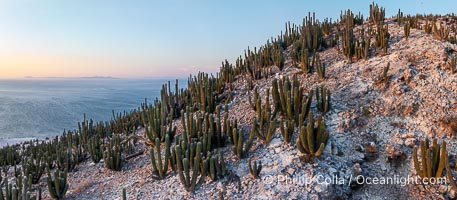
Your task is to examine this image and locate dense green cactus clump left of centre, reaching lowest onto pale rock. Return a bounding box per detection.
[168,105,232,191]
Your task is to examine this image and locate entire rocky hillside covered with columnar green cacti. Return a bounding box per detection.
[0,3,457,200]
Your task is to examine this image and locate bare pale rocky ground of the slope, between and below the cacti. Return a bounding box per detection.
[33,17,457,199]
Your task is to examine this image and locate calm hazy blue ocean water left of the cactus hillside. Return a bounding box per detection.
[0,78,182,138]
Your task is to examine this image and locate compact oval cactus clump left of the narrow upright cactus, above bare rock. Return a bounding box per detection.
[103,135,124,171]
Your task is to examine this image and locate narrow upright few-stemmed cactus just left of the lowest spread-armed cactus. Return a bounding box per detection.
[149,135,173,179]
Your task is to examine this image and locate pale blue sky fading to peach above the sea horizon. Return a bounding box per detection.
[0,0,457,78]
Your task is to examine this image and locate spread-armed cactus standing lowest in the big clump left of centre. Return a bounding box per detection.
[175,143,207,192]
